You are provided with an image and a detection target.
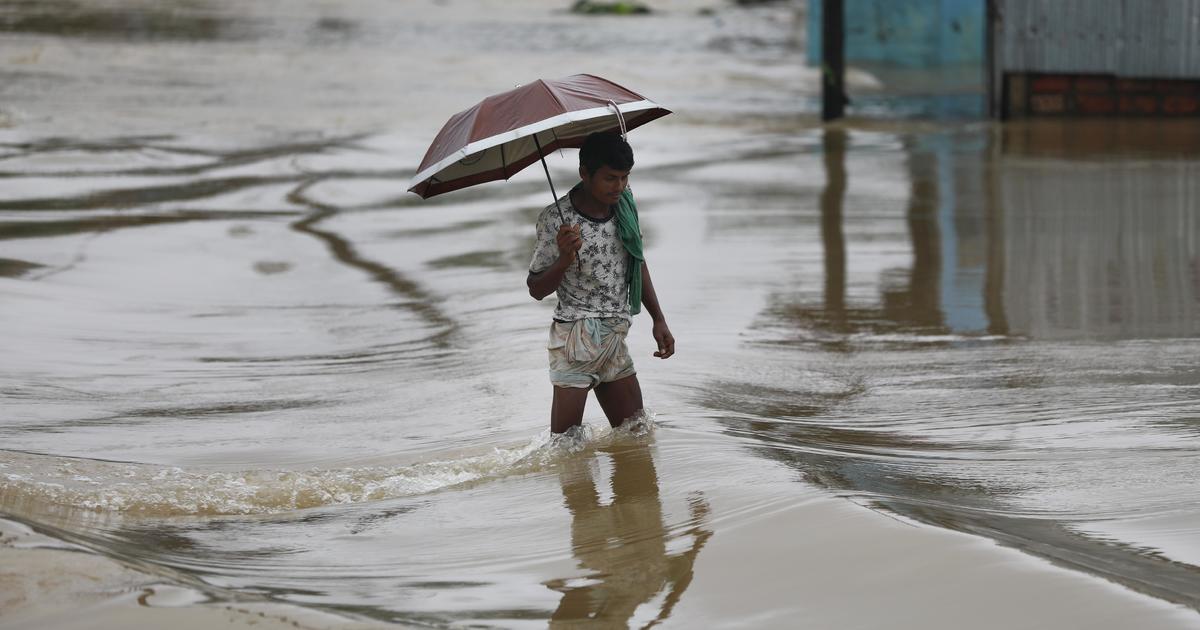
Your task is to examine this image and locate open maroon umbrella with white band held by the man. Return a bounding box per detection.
[409,74,671,219]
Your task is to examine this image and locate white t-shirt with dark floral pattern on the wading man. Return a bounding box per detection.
[529,193,630,322]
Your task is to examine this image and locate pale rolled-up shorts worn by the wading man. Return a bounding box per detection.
[546,317,637,389]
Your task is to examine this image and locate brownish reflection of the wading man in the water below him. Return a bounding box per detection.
[547,444,712,628]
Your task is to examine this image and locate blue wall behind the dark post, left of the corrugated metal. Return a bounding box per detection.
[808,0,986,68]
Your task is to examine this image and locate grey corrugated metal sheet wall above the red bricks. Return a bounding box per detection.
[996,0,1200,78]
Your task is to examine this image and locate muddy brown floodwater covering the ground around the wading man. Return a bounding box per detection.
[0,0,1200,629]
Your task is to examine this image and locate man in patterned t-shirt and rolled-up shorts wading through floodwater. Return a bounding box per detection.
[526,133,674,433]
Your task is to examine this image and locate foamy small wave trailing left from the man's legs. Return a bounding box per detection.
[0,414,654,516]
